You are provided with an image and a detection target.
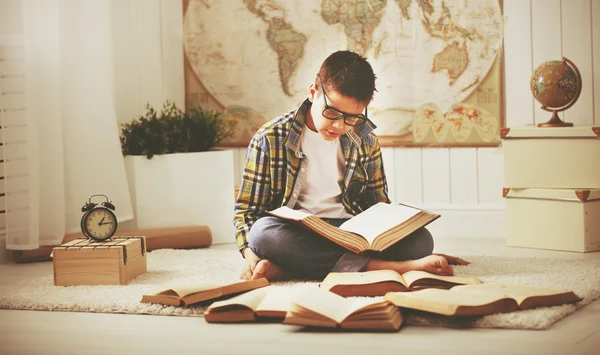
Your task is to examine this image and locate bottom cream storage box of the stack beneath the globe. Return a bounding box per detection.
[503,188,600,252]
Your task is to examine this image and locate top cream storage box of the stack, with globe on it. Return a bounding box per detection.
[500,126,600,189]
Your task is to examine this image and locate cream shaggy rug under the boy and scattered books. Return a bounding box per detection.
[0,248,600,329]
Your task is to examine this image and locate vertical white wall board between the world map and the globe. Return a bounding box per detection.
[504,0,533,127]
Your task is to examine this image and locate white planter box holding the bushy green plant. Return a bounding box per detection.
[125,150,235,244]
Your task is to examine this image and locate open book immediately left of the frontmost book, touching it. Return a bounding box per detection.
[204,286,292,323]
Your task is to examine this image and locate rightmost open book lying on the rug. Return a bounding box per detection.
[385,283,581,316]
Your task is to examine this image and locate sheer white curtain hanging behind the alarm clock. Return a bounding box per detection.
[0,0,133,250]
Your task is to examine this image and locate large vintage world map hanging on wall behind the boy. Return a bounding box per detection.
[183,0,503,143]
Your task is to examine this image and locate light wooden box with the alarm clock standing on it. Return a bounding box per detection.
[52,237,146,286]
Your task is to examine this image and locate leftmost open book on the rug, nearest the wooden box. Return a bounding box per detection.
[141,278,269,306]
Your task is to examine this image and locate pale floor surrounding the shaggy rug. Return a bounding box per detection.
[0,238,600,355]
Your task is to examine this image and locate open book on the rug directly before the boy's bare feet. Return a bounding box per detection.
[320,270,481,297]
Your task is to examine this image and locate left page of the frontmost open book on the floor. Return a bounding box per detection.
[292,289,354,324]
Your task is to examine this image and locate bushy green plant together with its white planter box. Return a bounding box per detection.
[120,101,236,243]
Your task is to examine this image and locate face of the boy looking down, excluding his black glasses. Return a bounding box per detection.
[306,83,365,141]
